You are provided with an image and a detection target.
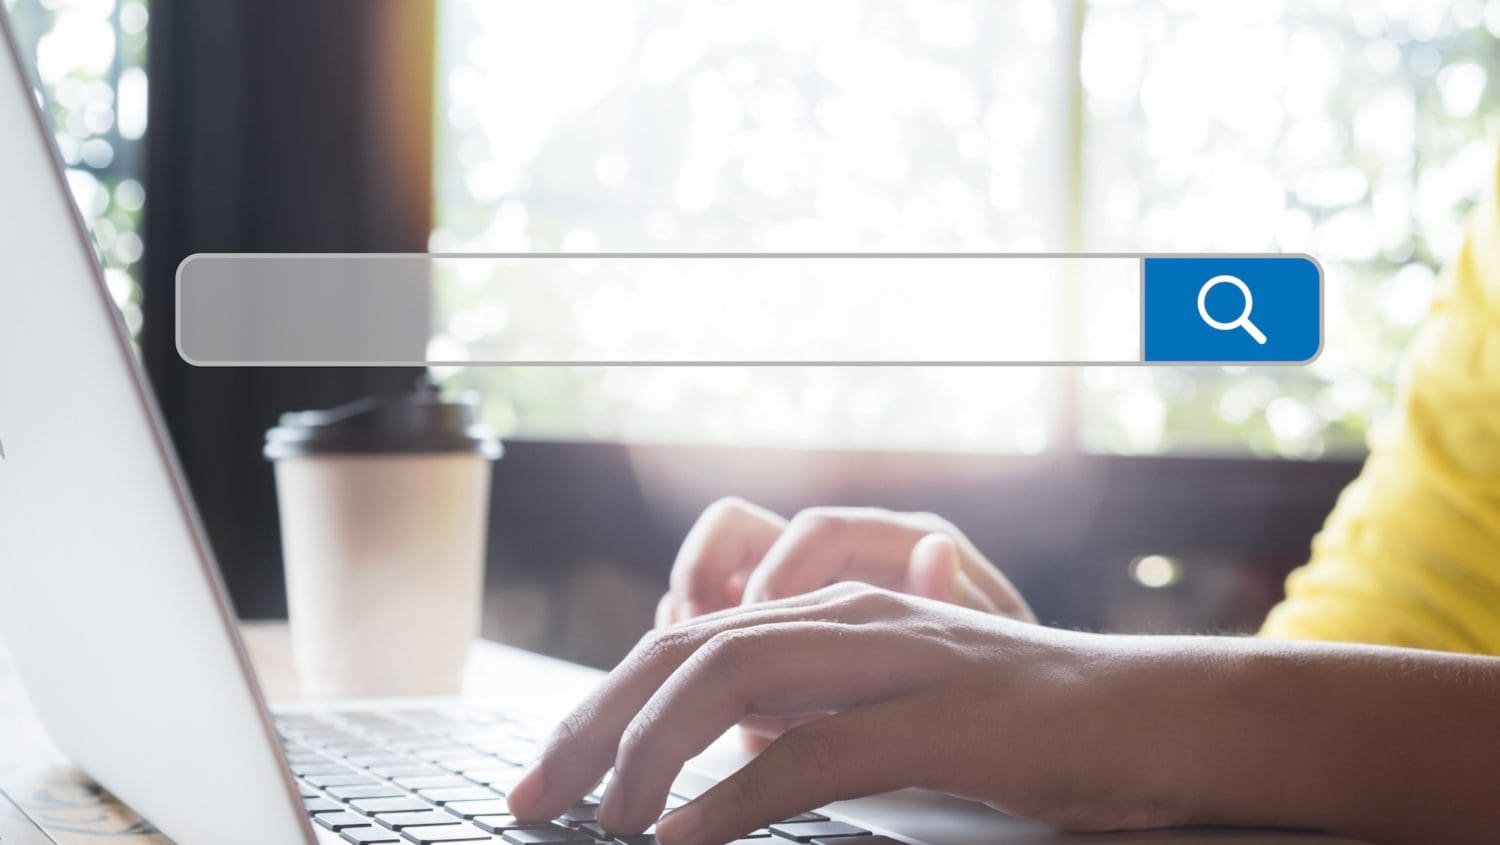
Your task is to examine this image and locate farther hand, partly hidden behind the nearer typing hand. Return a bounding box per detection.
[657,498,1037,627]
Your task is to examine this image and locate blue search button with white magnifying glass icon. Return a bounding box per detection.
[1142,255,1323,363]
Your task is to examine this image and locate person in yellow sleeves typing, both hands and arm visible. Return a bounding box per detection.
[509,160,1500,845]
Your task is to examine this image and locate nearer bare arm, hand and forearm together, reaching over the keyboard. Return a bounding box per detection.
[507,584,1500,845]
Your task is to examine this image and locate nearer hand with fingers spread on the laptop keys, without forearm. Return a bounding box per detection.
[509,585,1182,845]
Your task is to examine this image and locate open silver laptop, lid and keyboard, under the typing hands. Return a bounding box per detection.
[0,12,1362,845]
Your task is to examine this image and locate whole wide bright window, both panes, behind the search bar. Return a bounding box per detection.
[432,0,1500,458]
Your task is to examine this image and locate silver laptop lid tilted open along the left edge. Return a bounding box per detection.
[0,9,312,843]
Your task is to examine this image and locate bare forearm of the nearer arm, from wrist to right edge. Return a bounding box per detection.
[1116,638,1500,845]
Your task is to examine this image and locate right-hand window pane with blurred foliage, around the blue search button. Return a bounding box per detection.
[1080,0,1500,458]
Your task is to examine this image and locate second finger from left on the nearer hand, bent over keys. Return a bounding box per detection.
[599,621,935,833]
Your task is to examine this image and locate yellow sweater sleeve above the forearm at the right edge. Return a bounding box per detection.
[1262,156,1500,654]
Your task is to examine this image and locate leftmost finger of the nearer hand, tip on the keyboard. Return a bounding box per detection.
[507,588,876,821]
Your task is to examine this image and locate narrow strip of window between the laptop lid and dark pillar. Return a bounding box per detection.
[5,0,149,336]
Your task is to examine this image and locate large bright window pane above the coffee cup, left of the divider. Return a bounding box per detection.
[432,0,1064,452]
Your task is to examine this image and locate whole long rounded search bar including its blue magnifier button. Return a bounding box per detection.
[177,254,1323,366]
